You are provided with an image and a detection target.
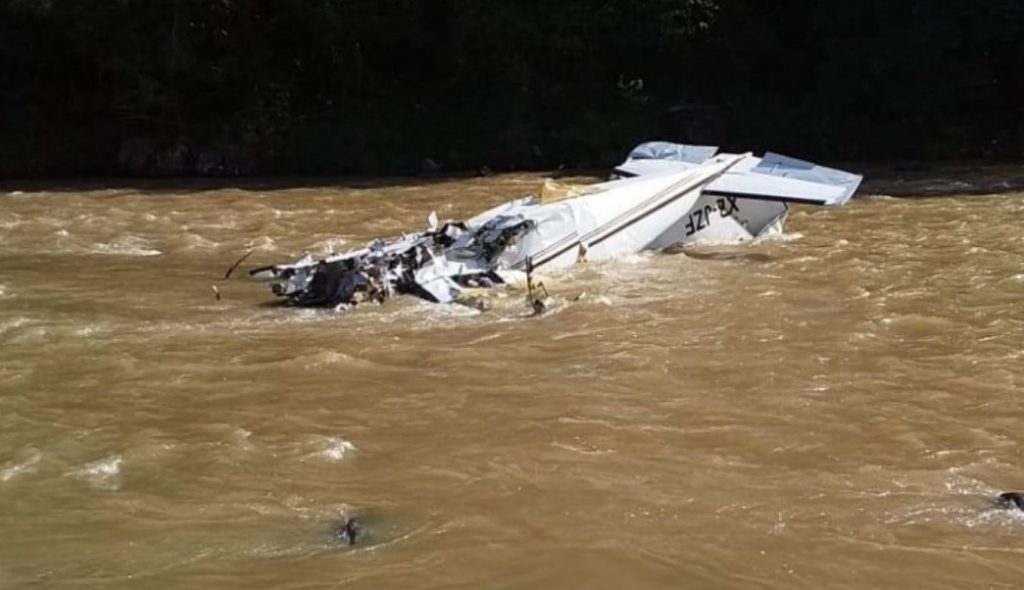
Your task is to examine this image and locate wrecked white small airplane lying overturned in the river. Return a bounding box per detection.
[250,141,862,307]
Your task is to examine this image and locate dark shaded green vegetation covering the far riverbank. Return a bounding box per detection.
[0,0,1024,176]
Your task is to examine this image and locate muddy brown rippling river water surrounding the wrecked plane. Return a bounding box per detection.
[0,175,1024,590]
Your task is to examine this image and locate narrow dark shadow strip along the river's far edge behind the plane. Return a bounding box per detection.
[6,162,1024,198]
